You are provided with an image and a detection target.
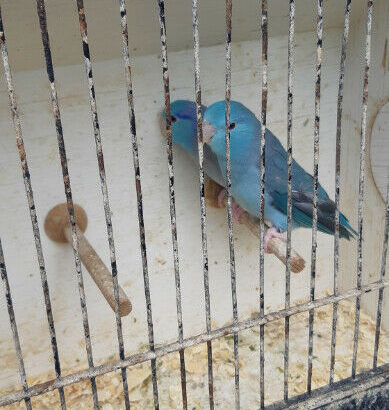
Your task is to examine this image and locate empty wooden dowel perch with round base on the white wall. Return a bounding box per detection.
[45,204,132,316]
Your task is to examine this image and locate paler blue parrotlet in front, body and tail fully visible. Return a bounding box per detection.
[200,101,357,251]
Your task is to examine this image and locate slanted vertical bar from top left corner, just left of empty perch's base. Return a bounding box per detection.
[0,8,66,409]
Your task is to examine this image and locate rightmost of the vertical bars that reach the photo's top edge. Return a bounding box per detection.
[351,0,373,378]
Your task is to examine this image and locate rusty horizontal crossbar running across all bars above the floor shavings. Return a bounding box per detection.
[0,281,389,407]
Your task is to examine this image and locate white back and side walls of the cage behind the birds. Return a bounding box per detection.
[0,0,389,408]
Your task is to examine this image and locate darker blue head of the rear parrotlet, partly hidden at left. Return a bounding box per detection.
[162,100,206,155]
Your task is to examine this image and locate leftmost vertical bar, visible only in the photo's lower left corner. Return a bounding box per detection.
[0,240,32,410]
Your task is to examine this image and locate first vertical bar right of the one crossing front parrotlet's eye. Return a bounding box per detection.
[259,0,268,409]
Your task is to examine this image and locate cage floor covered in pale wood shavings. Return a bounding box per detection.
[6,300,389,410]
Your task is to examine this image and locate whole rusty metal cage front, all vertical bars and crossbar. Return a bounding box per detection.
[0,0,389,410]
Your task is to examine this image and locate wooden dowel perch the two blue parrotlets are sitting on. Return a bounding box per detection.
[205,178,305,273]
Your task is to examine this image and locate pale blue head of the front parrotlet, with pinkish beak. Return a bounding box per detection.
[203,100,260,156]
